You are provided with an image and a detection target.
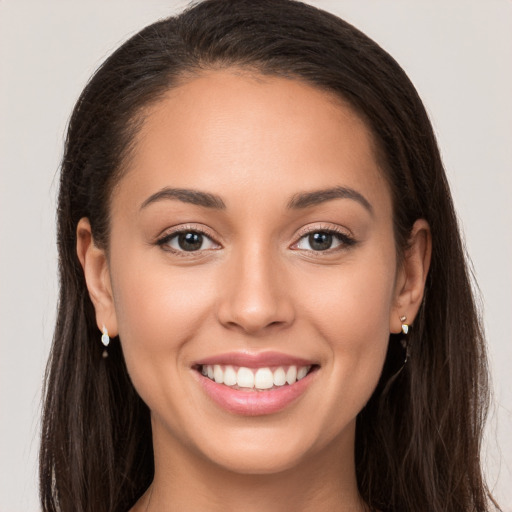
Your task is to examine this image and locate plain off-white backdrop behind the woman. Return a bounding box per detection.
[0,0,512,512]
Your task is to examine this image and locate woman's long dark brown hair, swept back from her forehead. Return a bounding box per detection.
[40,0,500,512]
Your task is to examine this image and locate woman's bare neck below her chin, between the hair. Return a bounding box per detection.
[133,418,367,512]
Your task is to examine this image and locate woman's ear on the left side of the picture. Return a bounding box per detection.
[76,217,118,337]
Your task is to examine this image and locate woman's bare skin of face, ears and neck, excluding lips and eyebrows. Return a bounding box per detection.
[77,69,431,512]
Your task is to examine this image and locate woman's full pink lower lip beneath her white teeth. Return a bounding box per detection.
[195,371,316,416]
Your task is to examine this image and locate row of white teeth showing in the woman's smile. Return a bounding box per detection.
[201,364,311,390]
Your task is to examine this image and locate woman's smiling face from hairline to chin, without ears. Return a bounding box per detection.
[104,70,400,473]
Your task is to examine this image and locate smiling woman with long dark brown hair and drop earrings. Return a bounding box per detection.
[41,0,500,511]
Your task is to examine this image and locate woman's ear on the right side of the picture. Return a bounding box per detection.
[389,219,432,333]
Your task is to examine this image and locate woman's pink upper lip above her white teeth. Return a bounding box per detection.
[194,351,315,368]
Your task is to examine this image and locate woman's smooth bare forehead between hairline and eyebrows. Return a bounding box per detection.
[114,70,390,216]
